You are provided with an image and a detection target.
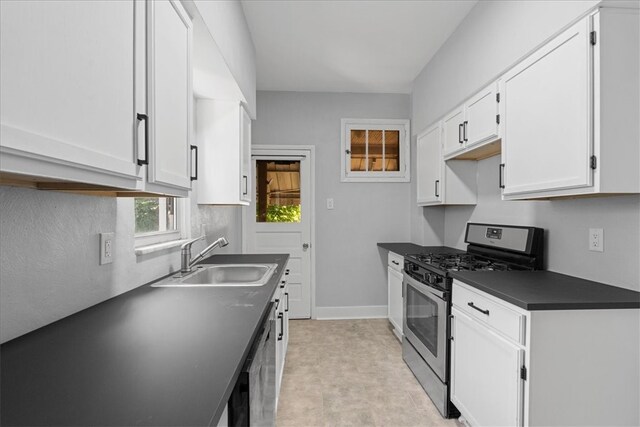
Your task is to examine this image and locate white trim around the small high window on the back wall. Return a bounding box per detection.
[340,119,411,182]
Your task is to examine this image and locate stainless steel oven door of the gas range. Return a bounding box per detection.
[402,274,449,383]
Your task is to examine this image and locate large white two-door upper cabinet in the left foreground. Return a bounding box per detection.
[0,0,192,196]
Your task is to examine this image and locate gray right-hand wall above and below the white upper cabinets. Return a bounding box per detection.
[411,1,640,289]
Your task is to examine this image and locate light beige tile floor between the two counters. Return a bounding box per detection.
[276,319,460,427]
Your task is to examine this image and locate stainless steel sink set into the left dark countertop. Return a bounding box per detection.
[151,264,278,288]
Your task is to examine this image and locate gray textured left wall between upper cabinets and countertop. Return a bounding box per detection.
[0,187,241,342]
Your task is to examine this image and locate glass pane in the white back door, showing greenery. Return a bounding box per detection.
[256,160,301,222]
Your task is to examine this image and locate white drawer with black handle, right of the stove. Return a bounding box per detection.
[452,281,525,344]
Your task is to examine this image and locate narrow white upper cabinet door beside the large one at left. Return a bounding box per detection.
[147,0,193,189]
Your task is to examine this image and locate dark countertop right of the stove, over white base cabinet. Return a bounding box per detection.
[450,271,640,311]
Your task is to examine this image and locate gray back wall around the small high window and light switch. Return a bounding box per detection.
[252,91,411,307]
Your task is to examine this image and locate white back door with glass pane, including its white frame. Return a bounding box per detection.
[242,147,313,319]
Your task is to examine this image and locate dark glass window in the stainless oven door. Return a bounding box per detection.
[406,286,438,357]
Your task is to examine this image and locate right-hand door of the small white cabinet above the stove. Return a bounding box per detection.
[462,83,500,148]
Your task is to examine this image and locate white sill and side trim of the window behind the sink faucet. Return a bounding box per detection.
[134,198,191,251]
